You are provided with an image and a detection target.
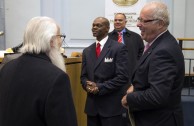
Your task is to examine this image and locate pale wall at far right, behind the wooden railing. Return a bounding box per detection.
[173,0,194,73]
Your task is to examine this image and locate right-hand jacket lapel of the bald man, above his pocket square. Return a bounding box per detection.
[94,39,111,70]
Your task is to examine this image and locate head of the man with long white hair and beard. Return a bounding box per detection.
[20,17,65,71]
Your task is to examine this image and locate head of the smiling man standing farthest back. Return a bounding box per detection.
[114,13,127,32]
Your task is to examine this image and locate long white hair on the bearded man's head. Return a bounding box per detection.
[20,17,58,54]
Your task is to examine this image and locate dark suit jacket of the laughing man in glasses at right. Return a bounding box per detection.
[127,31,185,126]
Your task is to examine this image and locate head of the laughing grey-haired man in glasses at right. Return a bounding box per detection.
[137,2,169,42]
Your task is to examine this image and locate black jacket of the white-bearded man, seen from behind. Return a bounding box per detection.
[0,54,77,126]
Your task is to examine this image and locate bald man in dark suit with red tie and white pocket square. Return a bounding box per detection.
[81,17,129,126]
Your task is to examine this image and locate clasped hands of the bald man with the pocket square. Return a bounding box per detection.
[86,81,99,94]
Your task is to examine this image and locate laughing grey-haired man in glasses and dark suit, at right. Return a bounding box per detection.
[122,2,185,126]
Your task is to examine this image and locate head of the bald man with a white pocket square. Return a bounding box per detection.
[92,17,110,41]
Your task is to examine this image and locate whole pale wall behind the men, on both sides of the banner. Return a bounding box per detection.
[1,0,194,60]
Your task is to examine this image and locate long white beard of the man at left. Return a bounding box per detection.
[48,47,66,72]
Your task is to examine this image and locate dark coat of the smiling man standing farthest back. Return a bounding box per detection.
[109,28,144,83]
